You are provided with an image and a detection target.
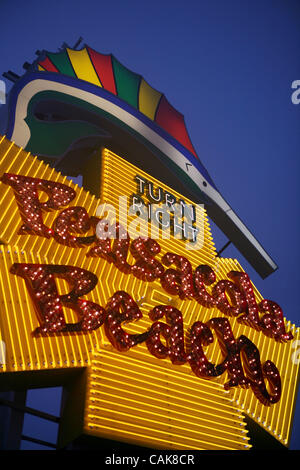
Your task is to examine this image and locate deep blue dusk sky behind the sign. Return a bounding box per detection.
[0,0,300,449]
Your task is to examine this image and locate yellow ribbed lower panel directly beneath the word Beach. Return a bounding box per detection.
[85,345,250,450]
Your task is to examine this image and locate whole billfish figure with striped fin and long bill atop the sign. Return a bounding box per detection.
[0,45,277,278]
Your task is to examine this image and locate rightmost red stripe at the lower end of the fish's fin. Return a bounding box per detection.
[155,96,198,158]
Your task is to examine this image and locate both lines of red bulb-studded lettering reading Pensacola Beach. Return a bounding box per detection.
[1,173,293,405]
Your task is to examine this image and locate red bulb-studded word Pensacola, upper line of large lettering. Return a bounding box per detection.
[1,173,293,342]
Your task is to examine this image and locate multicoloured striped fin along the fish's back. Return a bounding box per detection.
[37,46,198,158]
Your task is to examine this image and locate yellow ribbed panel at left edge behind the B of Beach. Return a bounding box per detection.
[0,245,96,372]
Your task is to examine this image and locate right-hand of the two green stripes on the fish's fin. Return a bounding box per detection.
[112,56,141,109]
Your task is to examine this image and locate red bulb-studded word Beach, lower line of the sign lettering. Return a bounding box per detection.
[11,263,284,405]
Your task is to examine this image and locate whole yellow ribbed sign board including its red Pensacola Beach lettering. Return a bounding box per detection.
[0,138,300,450]
